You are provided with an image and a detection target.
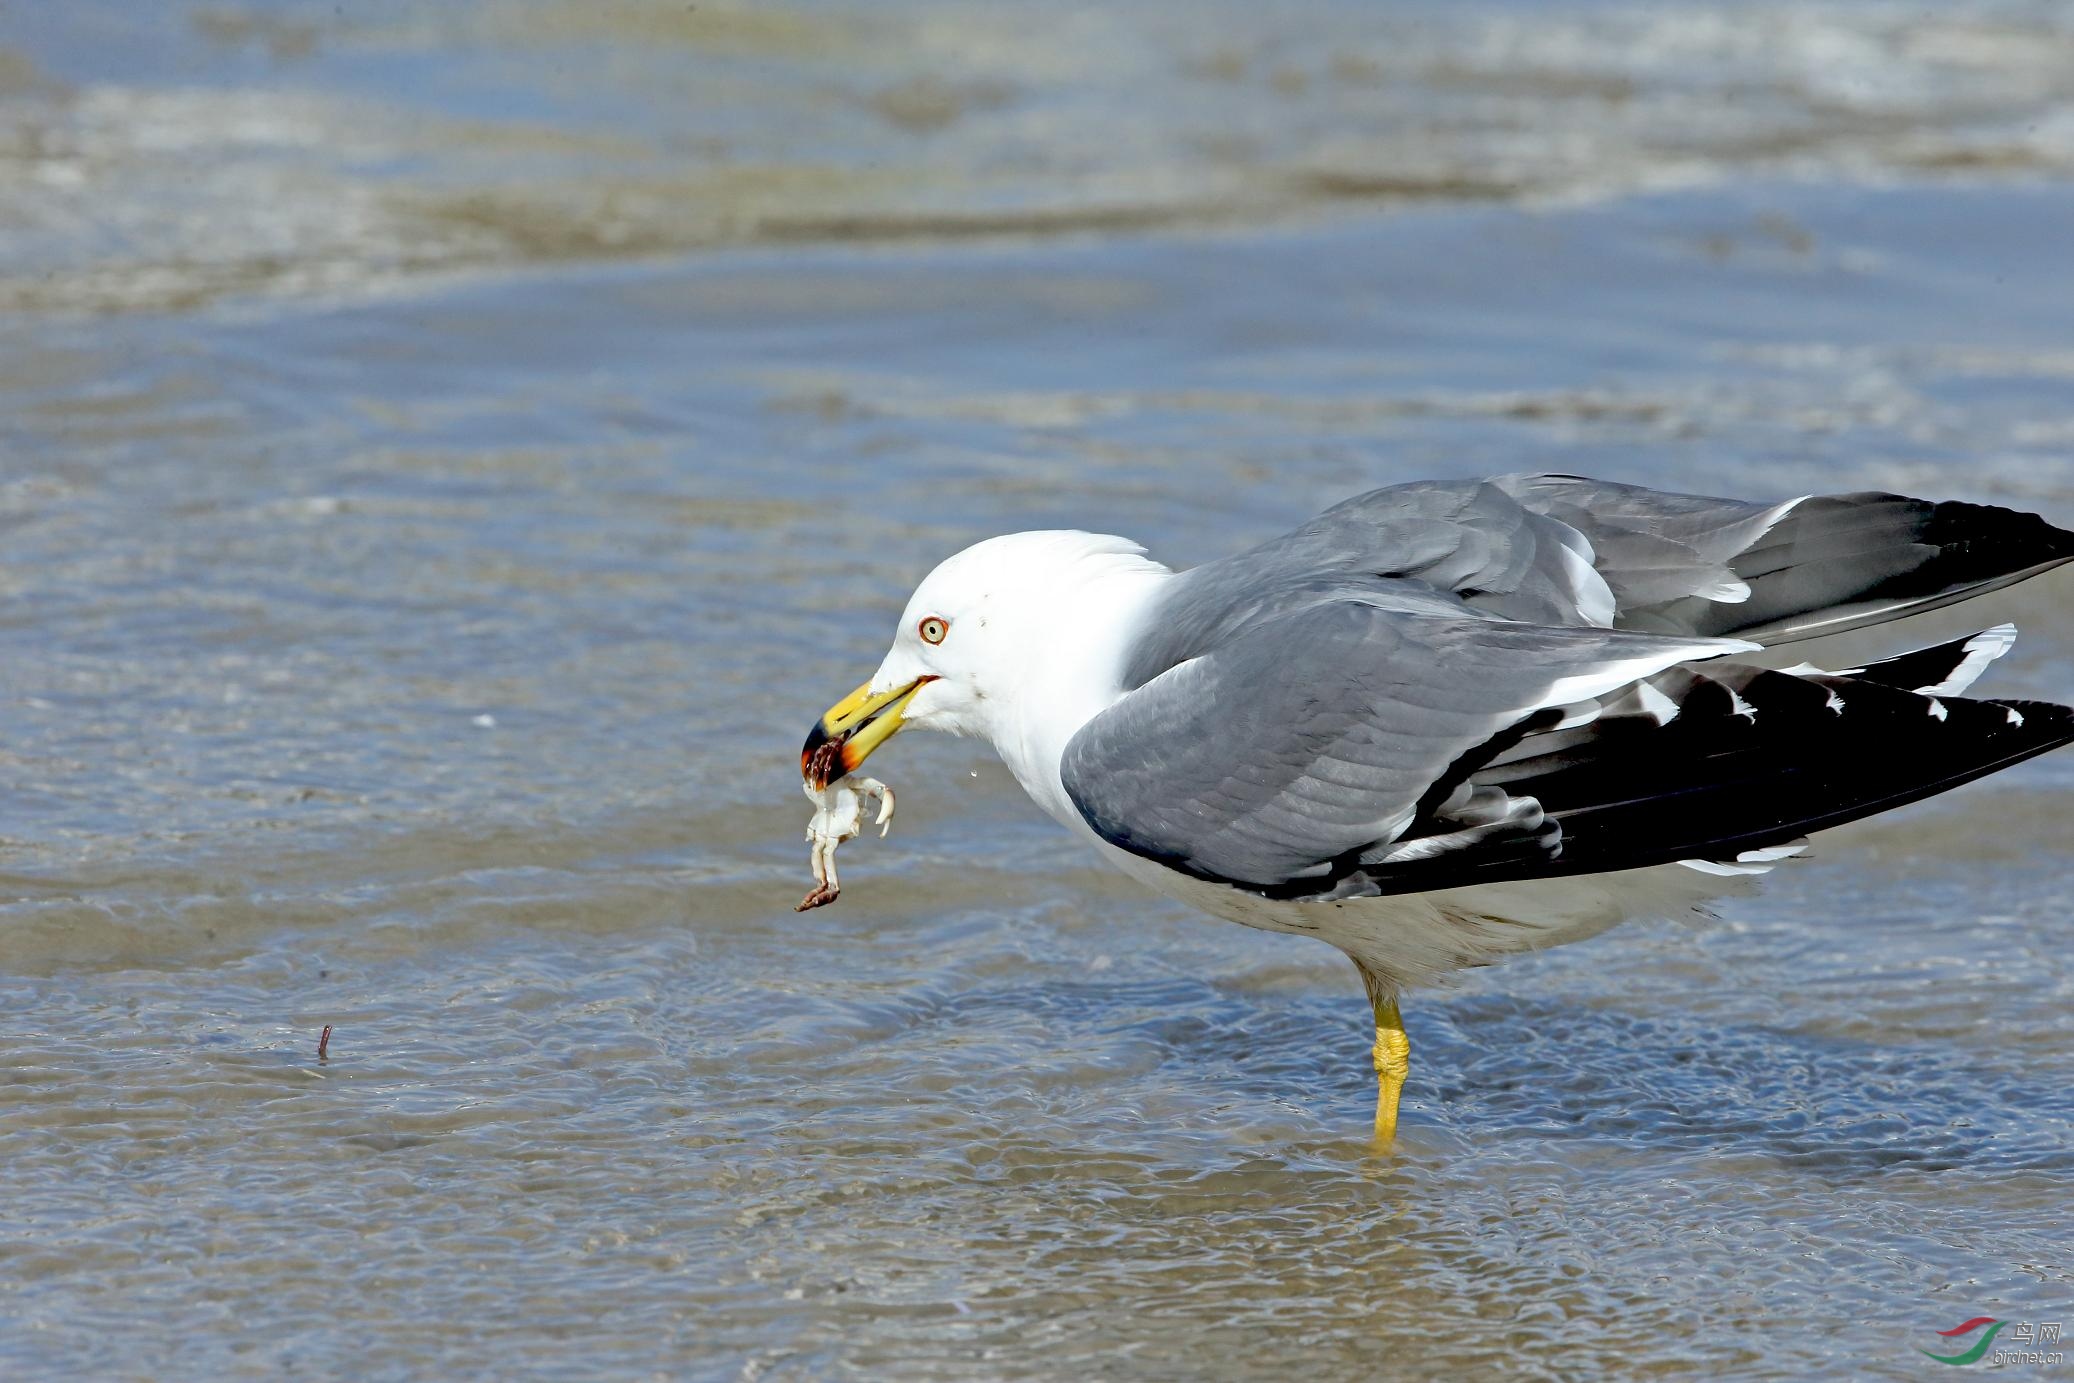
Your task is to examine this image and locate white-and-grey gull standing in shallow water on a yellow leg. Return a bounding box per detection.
[801,475,2074,1145]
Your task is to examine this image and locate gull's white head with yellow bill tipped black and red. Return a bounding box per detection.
[801,529,1170,786]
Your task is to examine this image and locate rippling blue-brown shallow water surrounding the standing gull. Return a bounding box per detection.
[0,0,2074,1377]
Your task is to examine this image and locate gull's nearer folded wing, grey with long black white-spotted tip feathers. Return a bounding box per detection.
[1060,601,2074,900]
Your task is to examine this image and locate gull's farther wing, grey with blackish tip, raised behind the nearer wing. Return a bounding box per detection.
[1124,475,2074,686]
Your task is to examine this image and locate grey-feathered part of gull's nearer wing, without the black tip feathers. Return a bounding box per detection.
[1060,599,1753,890]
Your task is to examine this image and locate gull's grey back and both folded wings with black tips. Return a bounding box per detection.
[1062,475,2074,898]
